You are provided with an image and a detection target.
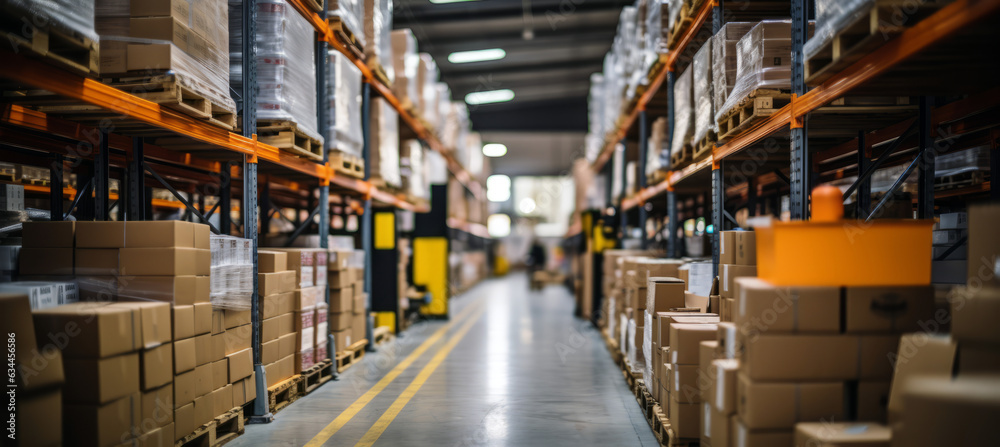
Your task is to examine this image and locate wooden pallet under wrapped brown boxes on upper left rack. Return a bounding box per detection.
[108,74,236,130]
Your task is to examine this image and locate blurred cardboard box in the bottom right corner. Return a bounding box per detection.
[892,378,1000,447]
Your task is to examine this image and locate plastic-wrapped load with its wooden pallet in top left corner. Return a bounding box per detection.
[0,0,100,76]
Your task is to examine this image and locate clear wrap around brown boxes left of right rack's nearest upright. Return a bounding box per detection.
[715,20,792,121]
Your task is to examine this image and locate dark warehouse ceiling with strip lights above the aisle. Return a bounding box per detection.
[393,0,632,175]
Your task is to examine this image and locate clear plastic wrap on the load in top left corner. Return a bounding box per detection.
[4,0,97,41]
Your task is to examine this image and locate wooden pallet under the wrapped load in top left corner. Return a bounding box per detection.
[0,7,100,76]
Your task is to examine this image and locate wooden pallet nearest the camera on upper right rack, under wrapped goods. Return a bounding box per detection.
[805,0,948,85]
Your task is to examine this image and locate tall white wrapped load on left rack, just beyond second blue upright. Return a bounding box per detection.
[326,50,364,157]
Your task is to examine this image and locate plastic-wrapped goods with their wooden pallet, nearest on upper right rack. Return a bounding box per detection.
[803,0,949,86]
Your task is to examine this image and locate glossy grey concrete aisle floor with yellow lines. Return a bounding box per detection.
[230,275,658,447]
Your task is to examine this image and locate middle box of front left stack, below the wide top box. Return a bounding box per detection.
[63,353,139,405]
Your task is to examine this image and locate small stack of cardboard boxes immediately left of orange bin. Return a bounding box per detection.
[719,231,757,321]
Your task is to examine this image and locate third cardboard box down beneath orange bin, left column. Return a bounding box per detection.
[737,375,846,429]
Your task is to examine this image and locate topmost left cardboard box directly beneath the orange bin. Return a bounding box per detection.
[735,277,841,334]
